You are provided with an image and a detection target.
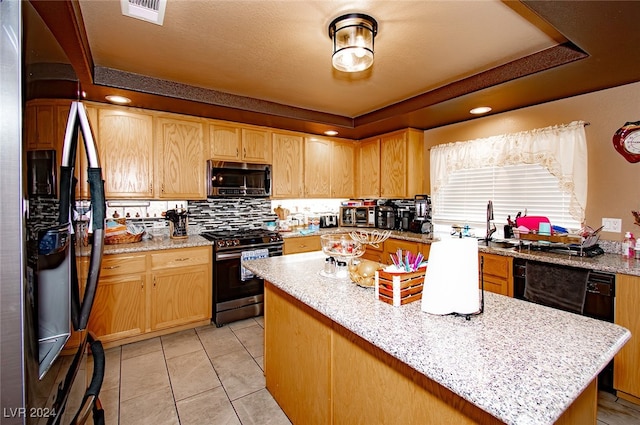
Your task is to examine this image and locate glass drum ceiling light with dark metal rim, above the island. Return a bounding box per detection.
[329,13,378,72]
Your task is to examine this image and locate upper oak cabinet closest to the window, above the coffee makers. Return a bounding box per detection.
[380,129,424,198]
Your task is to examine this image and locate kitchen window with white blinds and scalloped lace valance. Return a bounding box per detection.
[431,122,587,236]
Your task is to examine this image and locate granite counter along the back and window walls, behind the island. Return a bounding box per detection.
[282,227,640,276]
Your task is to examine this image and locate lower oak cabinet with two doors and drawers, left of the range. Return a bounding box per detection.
[88,246,212,344]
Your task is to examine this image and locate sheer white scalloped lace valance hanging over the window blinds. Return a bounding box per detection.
[430,121,587,222]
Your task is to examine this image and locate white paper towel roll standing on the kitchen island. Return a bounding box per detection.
[422,238,480,314]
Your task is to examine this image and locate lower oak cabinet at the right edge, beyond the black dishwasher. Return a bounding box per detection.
[613,274,640,403]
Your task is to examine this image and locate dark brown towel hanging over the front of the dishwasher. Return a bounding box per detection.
[524,261,589,314]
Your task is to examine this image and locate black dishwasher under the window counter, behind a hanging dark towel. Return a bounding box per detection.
[513,258,616,392]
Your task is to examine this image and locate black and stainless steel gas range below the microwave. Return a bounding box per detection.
[201,229,283,327]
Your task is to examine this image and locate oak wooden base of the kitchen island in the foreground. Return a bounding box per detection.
[264,281,597,425]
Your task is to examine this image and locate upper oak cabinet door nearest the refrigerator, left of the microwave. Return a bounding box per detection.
[97,107,154,198]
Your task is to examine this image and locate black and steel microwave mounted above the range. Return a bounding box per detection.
[207,160,271,198]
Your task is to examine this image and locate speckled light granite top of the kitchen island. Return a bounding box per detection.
[245,252,631,424]
